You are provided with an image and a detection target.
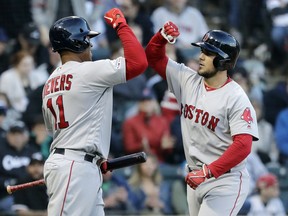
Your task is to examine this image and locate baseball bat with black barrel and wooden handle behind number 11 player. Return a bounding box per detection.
[6,152,146,194]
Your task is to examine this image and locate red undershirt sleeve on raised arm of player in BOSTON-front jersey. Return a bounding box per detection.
[145,32,168,80]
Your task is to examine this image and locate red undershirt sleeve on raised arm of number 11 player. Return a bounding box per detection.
[117,23,148,80]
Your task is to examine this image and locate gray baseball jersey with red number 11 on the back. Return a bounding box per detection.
[42,57,126,158]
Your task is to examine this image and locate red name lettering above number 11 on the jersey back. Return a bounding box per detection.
[43,74,73,96]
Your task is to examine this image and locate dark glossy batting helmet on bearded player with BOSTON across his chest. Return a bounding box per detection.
[191,30,240,70]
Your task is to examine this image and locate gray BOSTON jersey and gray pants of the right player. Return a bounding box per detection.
[166,59,258,216]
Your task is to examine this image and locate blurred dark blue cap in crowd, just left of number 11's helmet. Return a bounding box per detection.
[21,23,40,45]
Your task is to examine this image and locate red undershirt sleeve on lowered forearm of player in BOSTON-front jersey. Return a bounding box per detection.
[208,134,253,178]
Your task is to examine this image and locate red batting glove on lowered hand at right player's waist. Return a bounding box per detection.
[185,164,212,190]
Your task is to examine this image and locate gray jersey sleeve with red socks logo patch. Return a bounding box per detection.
[228,87,259,141]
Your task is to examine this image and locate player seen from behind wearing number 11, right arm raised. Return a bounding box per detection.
[42,8,148,216]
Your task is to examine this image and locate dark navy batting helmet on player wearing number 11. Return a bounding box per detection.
[49,16,100,53]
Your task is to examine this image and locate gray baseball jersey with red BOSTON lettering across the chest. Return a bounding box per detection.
[166,60,258,169]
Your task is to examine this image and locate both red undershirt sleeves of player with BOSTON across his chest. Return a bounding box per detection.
[145,32,253,178]
